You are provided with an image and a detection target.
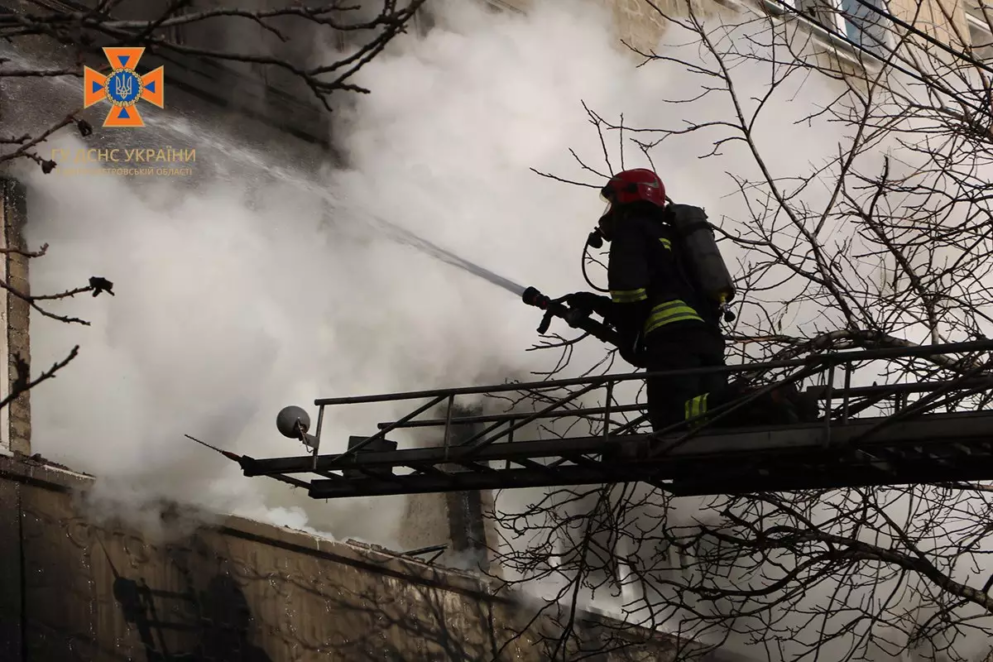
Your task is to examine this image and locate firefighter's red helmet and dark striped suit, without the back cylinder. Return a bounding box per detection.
[566,169,727,430]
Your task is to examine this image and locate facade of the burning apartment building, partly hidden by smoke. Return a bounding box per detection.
[0,0,993,661]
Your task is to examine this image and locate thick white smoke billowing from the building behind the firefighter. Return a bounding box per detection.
[9,0,992,660]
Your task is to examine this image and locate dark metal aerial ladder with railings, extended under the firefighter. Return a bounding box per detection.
[197,288,993,499]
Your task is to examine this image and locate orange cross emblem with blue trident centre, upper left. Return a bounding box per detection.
[83,48,165,127]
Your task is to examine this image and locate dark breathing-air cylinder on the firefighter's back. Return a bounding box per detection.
[669,204,735,315]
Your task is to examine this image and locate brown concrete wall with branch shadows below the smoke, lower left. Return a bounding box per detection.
[0,458,688,662]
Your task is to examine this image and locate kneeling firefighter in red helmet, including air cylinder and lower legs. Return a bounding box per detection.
[565,169,818,431]
